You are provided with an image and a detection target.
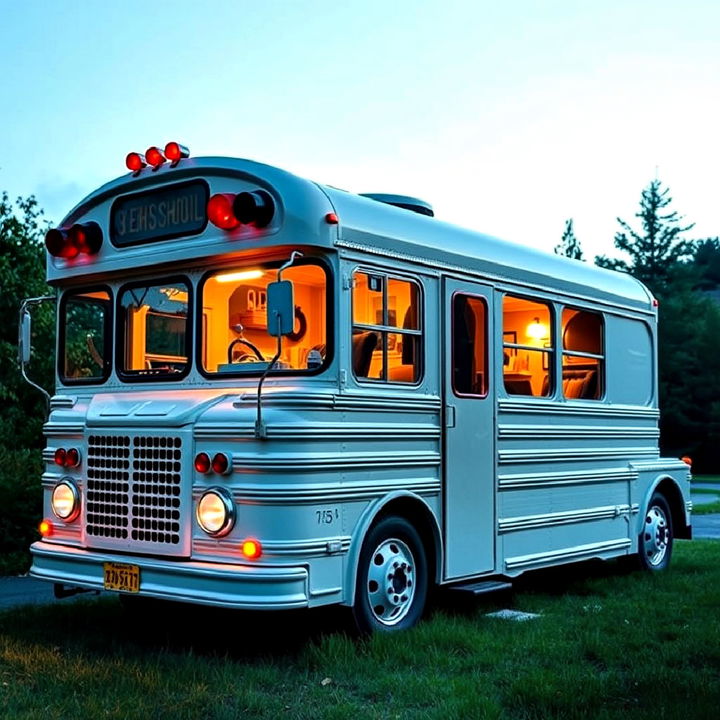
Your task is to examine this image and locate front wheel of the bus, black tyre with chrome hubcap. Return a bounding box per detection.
[353,517,428,633]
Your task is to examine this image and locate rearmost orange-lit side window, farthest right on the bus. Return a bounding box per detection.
[562,308,605,400]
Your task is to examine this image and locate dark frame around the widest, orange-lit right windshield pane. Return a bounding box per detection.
[195,255,335,381]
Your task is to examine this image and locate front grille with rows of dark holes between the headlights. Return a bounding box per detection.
[85,435,182,547]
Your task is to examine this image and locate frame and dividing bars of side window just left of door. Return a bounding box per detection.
[349,265,425,388]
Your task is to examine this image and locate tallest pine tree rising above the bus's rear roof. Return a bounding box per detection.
[595,180,695,294]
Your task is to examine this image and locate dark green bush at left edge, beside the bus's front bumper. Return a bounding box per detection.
[0,446,43,575]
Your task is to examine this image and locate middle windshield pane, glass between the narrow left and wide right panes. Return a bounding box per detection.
[118,281,190,379]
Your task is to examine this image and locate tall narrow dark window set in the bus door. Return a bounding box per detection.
[452,293,488,397]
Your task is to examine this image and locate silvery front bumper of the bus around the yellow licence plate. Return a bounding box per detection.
[30,541,309,610]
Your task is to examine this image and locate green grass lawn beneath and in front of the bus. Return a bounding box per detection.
[0,541,720,720]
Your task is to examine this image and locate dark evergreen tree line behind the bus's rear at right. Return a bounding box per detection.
[555,180,720,473]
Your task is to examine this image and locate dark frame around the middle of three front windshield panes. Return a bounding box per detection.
[115,275,195,383]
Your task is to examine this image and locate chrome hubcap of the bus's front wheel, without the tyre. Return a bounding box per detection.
[366,538,415,625]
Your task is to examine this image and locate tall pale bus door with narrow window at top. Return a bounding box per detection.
[443,278,495,579]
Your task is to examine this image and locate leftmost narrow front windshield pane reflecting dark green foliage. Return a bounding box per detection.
[59,290,112,384]
